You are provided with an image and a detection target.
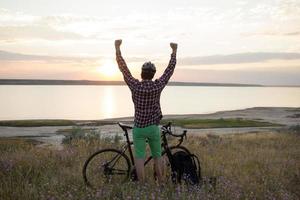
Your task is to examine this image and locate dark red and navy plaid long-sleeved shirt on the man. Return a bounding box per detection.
[116,51,176,128]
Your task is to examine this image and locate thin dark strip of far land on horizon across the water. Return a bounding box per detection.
[0,79,265,87]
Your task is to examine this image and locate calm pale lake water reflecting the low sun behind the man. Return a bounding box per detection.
[0,85,300,120]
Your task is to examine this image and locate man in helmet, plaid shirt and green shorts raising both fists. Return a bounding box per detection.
[115,40,177,183]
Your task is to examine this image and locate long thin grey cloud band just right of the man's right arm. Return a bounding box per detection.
[178,52,300,65]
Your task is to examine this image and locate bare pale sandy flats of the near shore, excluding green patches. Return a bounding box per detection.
[0,107,300,145]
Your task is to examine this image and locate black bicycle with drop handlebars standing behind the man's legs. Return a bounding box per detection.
[82,122,201,188]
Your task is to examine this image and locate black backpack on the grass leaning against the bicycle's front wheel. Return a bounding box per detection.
[172,151,202,185]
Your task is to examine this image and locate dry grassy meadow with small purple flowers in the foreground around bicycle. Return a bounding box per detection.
[0,132,300,200]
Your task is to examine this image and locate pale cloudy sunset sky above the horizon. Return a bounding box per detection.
[0,0,300,85]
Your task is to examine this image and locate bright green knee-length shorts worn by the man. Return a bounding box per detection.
[132,125,161,158]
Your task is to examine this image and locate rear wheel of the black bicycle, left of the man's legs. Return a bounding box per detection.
[82,149,130,189]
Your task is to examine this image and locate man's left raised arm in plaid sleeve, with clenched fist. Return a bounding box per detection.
[115,40,138,88]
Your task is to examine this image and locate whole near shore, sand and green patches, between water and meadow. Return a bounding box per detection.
[0,107,300,146]
